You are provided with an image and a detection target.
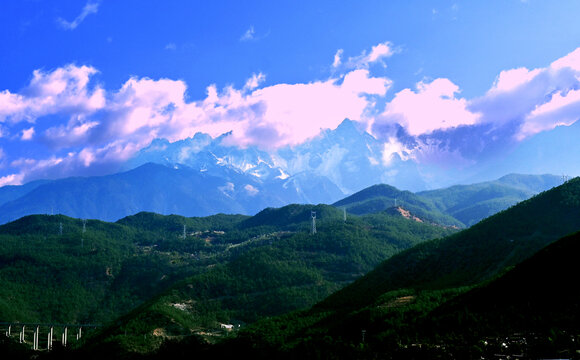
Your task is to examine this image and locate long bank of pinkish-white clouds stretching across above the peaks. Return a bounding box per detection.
[0,43,580,186]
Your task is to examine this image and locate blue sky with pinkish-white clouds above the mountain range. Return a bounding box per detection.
[0,0,580,186]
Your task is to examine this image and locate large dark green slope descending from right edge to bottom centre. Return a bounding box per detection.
[205,178,580,359]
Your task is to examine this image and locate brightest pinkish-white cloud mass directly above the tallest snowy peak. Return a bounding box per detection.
[234,70,391,147]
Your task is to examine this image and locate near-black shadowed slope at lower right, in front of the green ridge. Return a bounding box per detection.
[431,233,580,336]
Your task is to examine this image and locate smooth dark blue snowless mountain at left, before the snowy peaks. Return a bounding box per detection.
[0,164,243,222]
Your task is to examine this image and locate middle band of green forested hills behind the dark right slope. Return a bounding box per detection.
[0,205,454,351]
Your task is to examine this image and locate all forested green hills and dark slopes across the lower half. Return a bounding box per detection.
[0,178,580,359]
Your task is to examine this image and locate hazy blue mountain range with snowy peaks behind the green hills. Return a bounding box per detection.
[0,120,580,222]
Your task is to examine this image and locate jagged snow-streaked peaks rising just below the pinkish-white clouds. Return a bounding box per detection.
[126,119,426,202]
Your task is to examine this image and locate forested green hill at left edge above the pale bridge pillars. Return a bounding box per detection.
[0,213,246,323]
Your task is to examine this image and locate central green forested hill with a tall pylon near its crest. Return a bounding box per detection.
[78,205,452,351]
